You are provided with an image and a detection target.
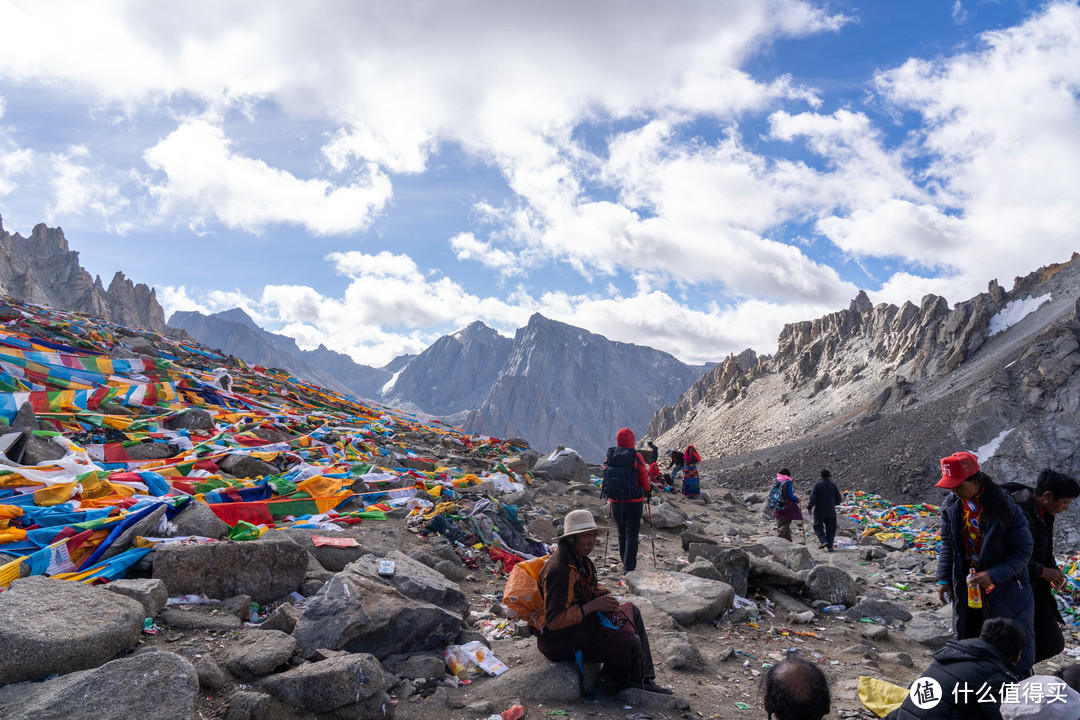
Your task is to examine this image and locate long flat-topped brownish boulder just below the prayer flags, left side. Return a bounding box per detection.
[153,538,308,604]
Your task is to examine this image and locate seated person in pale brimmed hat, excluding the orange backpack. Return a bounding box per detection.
[537,509,672,695]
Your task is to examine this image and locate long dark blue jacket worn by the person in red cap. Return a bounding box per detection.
[937,483,1035,677]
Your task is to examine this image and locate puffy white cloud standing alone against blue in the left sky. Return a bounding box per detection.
[143,120,391,235]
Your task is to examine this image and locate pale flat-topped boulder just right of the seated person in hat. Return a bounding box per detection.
[625,570,735,625]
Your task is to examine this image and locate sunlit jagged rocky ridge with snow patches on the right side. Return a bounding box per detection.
[649,255,1080,511]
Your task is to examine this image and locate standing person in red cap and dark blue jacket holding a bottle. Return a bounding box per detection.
[937,452,1035,677]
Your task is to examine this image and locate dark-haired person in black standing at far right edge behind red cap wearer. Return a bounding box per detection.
[1002,467,1080,663]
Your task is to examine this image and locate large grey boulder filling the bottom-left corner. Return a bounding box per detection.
[0,647,199,720]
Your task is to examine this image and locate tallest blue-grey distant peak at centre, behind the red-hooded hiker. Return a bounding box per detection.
[460,314,702,461]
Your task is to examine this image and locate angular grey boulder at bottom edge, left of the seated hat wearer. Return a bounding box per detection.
[256,653,393,718]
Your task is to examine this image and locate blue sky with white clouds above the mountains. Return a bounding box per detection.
[0,0,1080,367]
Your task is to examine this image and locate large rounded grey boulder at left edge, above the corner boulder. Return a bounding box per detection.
[0,575,146,686]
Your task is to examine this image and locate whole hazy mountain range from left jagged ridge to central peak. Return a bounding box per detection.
[0,212,706,462]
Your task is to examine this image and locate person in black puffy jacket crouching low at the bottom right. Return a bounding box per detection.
[886,617,1027,720]
